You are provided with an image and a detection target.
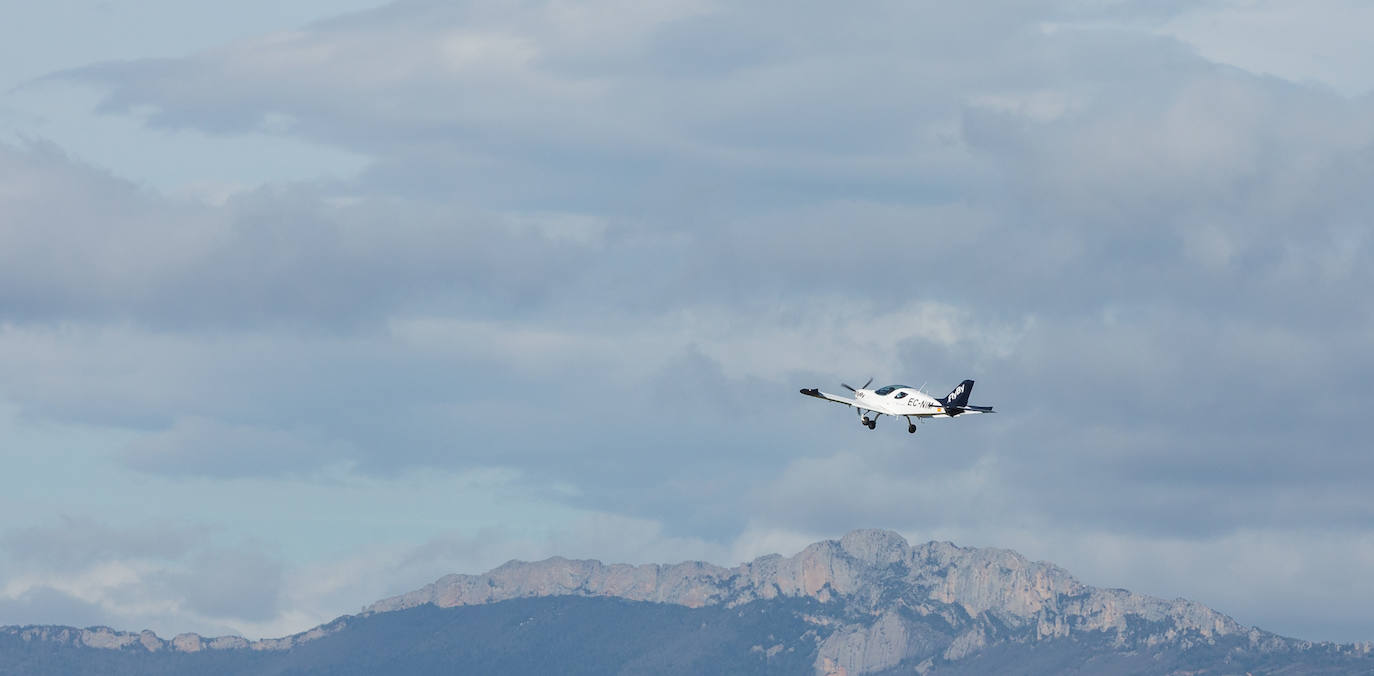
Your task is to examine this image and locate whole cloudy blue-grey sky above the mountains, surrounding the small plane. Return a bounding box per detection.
[0,0,1374,642]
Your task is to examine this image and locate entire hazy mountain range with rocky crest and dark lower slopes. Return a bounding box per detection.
[0,530,1374,675]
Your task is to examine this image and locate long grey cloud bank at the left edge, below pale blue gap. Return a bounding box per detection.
[0,144,632,330]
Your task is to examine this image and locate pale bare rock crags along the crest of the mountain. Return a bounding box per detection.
[365,530,1246,638]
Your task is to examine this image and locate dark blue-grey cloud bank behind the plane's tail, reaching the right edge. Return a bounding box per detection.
[747,291,1374,540]
